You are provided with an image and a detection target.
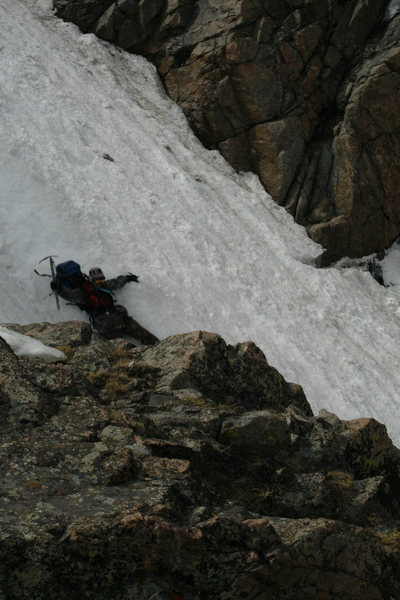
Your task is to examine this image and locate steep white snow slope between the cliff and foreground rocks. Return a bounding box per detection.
[0,0,400,442]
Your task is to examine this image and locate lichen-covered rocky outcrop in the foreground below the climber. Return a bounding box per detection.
[0,322,400,600]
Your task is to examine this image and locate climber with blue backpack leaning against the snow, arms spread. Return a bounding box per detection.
[51,261,159,345]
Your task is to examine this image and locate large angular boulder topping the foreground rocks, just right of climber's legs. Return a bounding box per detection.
[142,331,312,414]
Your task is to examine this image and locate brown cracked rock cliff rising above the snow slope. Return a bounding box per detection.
[54,0,400,263]
